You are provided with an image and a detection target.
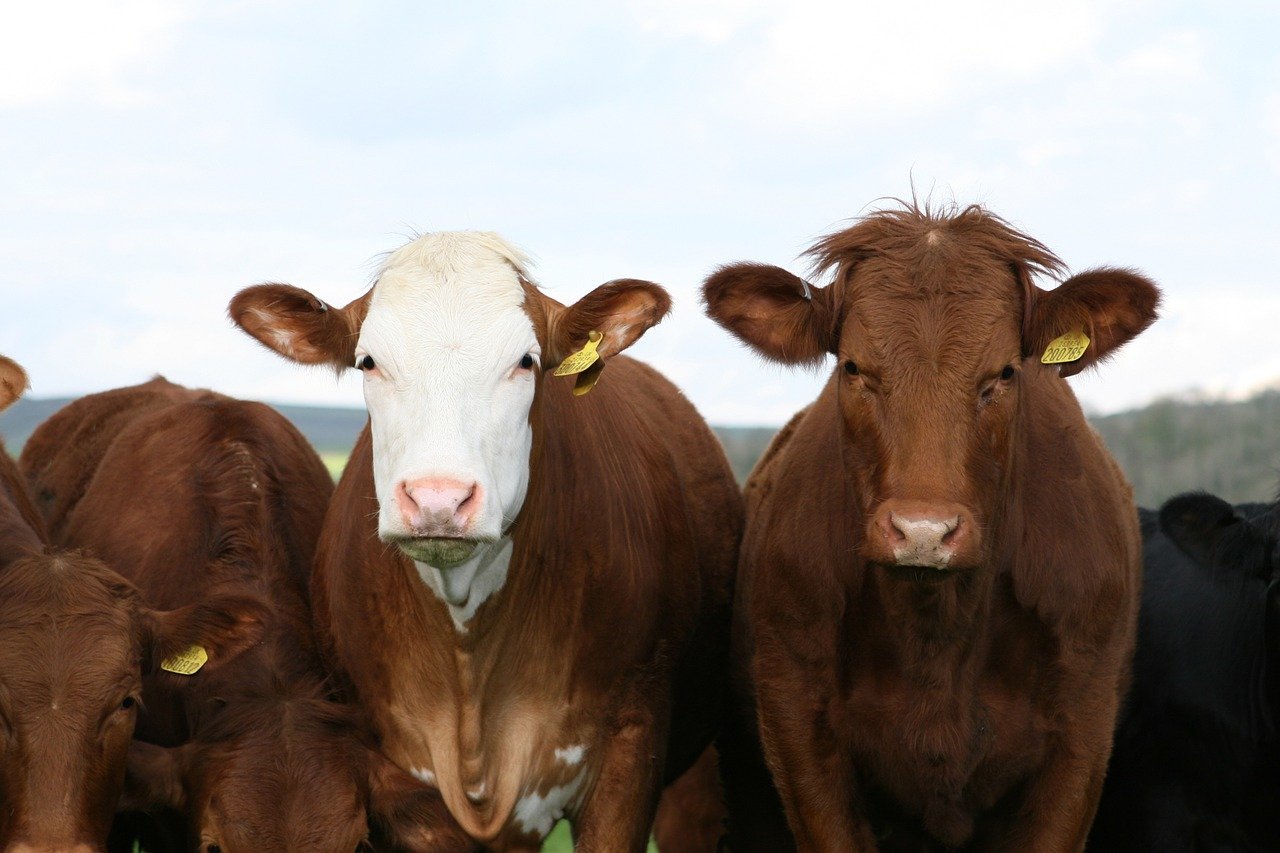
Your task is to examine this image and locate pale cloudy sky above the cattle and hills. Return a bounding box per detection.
[0,0,1280,425]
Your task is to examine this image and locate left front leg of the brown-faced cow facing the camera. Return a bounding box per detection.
[751,624,877,853]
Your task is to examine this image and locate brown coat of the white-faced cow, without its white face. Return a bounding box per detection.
[233,274,741,852]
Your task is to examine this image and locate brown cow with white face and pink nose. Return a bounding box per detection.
[229,232,741,852]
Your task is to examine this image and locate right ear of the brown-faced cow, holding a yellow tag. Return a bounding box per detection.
[1024,268,1160,377]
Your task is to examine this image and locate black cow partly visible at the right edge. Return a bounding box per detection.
[1089,493,1280,853]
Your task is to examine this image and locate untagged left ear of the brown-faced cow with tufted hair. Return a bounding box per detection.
[703,263,838,364]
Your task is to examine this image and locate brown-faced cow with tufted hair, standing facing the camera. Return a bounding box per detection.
[704,205,1158,850]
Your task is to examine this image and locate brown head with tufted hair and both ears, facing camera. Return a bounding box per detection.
[704,207,1158,580]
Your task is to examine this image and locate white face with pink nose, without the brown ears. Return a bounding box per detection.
[356,232,541,569]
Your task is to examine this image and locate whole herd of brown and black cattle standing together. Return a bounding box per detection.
[0,202,1280,853]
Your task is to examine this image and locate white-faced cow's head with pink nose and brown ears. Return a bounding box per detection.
[229,232,669,603]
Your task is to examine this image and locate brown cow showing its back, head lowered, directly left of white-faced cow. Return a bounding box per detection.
[20,378,470,853]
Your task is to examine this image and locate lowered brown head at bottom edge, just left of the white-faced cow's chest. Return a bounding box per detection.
[122,698,474,853]
